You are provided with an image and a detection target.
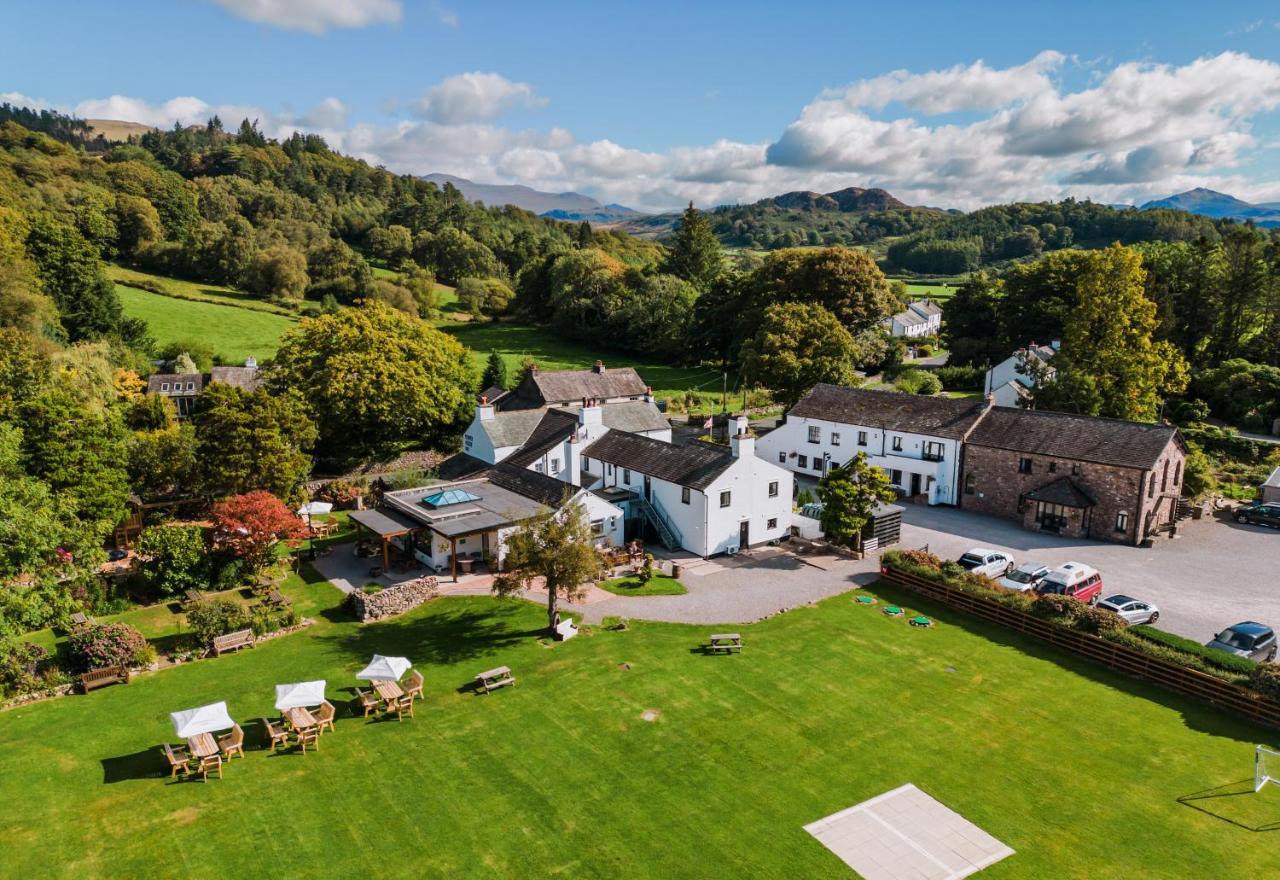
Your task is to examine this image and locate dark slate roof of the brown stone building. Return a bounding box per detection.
[969,407,1178,471]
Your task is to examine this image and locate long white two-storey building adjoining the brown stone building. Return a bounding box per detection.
[756,384,988,504]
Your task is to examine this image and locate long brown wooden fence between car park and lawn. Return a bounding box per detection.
[881,563,1280,729]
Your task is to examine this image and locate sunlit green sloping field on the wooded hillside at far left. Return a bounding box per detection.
[115,284,293,363]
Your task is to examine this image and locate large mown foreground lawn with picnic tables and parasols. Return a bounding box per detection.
[0,581,1280,880]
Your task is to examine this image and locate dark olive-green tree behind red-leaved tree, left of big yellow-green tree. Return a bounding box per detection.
[191,382,316,498]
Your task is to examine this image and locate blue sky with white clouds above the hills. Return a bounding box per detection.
[0,0,1280,211]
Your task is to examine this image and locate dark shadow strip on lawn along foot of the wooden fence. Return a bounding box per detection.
[850,576,1272,746]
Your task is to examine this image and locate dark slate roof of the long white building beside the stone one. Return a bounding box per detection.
[787,384,984,439]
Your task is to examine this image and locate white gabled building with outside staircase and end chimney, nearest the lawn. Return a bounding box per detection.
[580,417,792,556]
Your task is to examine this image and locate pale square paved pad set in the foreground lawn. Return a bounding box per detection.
[804,783,1014,880]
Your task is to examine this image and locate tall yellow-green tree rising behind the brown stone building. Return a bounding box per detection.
[1034,244,1188,422]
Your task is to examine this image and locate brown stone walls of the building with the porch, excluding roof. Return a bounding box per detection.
[960,443,1184,544]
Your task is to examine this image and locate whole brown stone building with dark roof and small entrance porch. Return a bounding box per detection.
[960,407,1187,545]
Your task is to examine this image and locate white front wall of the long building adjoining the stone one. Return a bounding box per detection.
[755,416,960,504]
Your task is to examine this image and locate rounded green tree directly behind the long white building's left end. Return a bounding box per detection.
[742,303,860,407]
